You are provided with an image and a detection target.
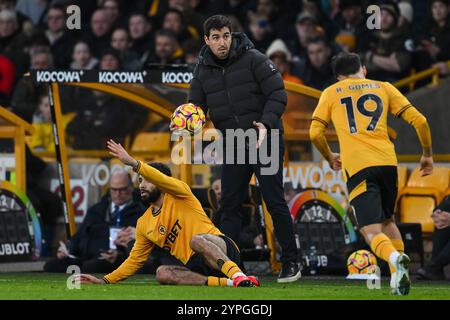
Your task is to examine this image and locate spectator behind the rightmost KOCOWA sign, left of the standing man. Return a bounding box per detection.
[145,29,184,67]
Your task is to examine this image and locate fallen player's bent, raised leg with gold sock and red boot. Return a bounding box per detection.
[190,234,259,286]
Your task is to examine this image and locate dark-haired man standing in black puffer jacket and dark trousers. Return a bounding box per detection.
[189,15,301,282]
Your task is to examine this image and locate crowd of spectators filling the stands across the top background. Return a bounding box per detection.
[0,0,450,141]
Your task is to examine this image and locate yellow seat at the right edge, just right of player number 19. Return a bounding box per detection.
[398,167,450,233]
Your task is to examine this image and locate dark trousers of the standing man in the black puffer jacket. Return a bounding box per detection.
[220,135,297,263]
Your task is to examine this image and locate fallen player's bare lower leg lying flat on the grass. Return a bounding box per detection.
[156,265,208,285]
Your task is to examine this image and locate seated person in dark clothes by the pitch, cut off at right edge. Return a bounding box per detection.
[417,197,450,280]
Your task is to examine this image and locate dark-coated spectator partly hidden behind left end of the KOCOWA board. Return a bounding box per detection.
[11,48,53,122]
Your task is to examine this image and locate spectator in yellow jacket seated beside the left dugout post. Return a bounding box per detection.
[28,94,75,153]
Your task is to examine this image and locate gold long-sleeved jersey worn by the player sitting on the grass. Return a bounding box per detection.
[103,162,223,283]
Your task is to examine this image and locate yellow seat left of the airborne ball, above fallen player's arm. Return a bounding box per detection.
[131,132,170,154]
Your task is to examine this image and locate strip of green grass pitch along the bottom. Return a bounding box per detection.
[0,272,450,300]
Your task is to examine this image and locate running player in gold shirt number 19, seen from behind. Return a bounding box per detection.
[310,53,433,295]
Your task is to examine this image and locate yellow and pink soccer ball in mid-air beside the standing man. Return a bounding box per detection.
[171,103,206,135]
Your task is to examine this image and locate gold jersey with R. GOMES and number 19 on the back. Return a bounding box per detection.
[313,78,411,178]
